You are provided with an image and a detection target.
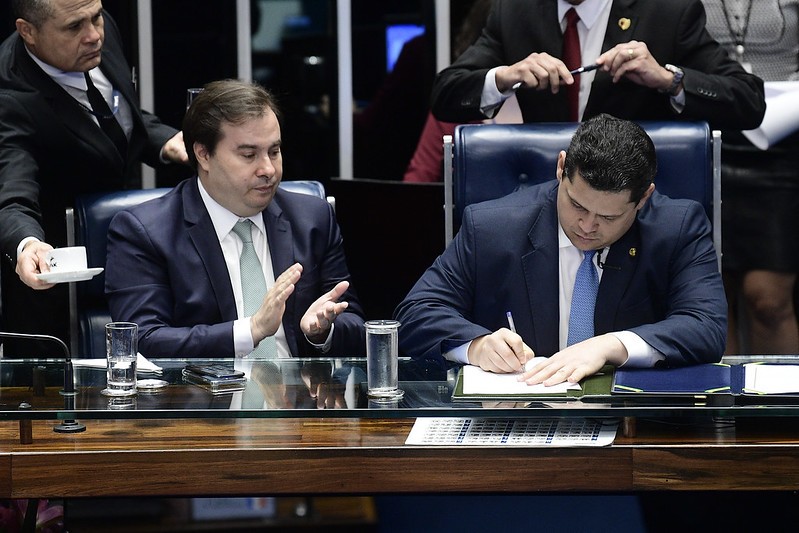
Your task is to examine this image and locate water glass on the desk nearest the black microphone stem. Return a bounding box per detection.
[103,322,139,396]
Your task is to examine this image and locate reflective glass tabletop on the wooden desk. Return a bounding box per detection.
[0,356,799,420]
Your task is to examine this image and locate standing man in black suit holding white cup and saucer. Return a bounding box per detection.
[0,0,187,355]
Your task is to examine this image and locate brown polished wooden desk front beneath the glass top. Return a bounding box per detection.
[0,418,799,498]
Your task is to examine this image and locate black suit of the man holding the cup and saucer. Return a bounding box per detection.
[0,13,177,340]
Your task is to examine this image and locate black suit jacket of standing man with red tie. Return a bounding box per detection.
[432,0,766,130]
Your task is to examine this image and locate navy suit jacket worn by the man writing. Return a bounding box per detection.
[395,180,727,365]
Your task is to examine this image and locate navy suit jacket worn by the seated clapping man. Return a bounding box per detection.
[105,178,366,357]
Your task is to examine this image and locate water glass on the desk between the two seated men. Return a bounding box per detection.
[365,320,404,400]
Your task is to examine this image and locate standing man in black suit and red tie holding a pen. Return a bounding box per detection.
[432,0,766,130]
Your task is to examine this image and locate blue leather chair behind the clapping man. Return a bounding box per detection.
[66,180,335,358]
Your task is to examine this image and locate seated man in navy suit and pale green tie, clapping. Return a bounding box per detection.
[105,80,365,357]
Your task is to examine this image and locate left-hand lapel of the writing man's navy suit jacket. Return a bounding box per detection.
[522,187,560,355]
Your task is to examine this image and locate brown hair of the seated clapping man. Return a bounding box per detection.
[183,80,280,171]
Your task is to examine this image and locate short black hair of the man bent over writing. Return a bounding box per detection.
[563,114,657,204]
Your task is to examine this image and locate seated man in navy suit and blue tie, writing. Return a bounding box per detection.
[396,115,727,385]
